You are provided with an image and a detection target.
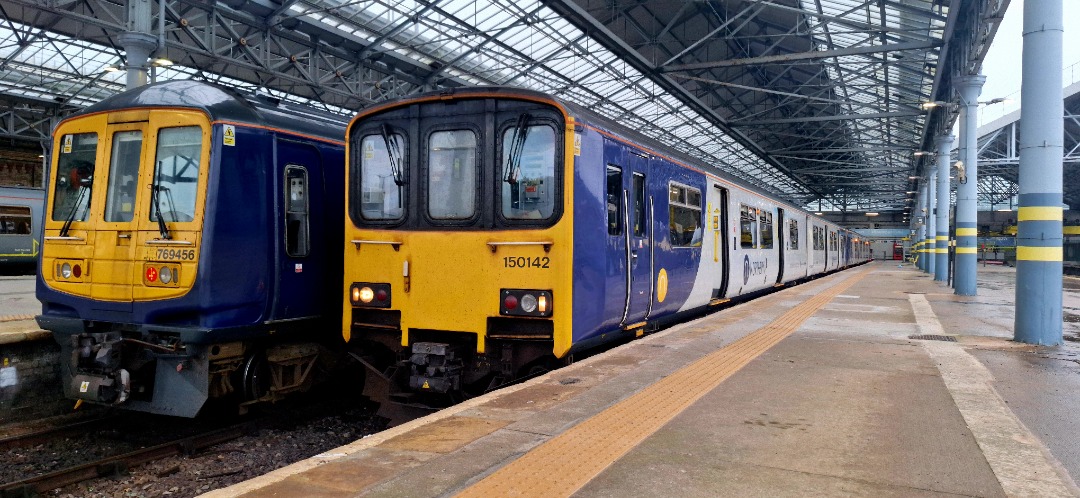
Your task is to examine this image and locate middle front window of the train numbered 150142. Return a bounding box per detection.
[428,130,476,220]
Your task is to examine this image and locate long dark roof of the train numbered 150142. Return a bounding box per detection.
[361,86,806,211]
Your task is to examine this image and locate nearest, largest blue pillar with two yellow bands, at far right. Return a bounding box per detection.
[1013,0,1065,346]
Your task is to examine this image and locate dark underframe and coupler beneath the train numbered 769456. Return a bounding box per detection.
[46,321,330,417]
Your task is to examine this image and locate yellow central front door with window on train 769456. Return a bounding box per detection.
[89,120,152,306]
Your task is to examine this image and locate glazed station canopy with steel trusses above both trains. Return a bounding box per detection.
[0,0,1009,212]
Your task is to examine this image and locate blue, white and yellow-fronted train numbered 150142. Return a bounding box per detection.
[342,88,870,404]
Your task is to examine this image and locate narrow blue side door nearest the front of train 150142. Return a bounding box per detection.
[623,153,654,328]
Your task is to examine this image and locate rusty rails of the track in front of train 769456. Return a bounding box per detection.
[0,420,252,498]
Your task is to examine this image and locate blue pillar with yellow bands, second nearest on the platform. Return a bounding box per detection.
[954,75,986,296]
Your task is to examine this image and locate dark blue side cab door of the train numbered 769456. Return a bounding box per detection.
[273,139,319,319]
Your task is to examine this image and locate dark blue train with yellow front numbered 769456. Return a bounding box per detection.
[37,81,346,416]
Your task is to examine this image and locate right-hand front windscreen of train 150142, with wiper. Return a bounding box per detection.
[499,122,558,220]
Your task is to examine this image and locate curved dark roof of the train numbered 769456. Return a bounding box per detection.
[71,80,348,142]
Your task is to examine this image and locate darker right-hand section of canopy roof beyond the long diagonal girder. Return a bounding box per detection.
[545,0,1008,211]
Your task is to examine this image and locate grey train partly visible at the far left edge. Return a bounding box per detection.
[0,187,44,268]
